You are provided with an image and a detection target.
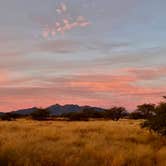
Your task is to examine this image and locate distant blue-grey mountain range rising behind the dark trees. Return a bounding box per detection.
[9,104,104,115]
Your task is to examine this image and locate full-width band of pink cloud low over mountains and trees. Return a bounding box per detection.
[0,68,166,111]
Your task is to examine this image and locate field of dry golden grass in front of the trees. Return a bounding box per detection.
[0,120,166,166]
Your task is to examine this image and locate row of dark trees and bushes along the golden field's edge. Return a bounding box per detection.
[1,97,166,135]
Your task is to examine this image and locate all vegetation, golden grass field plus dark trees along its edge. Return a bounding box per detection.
[0,98,166,166]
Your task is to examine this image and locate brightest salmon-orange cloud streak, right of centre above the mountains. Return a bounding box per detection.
[70,75,166,96]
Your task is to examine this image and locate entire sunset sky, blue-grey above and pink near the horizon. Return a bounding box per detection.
[0,0,166,112]
